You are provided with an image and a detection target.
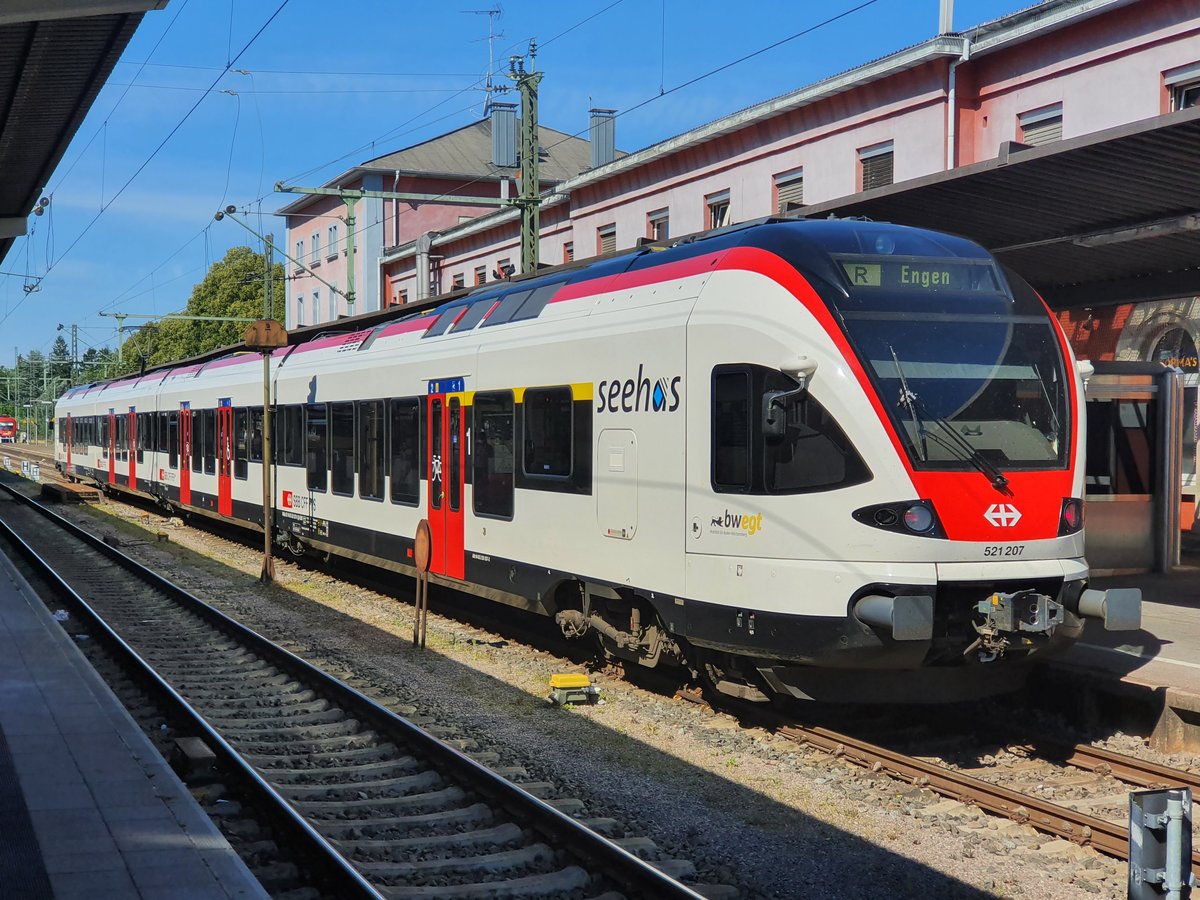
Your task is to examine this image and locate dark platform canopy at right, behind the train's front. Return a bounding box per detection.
[803,108,1200,310]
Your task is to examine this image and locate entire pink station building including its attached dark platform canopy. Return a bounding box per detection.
[281,0,1200,526]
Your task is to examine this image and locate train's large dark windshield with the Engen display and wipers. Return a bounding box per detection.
[834,254,1070,468]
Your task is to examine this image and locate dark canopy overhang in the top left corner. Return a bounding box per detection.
[0,0,167,262]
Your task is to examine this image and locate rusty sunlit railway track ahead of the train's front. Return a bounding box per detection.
[678,690,1200,876]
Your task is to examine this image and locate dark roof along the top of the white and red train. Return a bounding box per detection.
[62,217,989,400]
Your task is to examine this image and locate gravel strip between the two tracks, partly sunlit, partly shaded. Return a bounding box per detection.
[49,502,1127,900]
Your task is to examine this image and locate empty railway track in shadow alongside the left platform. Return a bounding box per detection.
[0,484,736,900]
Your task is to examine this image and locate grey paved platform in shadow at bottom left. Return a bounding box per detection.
[0,554,269,900]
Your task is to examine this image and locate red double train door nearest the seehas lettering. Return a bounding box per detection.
[426,391,466,578]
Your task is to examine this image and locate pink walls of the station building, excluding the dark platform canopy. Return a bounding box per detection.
[284,0,1200,494]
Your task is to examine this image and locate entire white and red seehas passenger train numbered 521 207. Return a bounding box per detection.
[56,220,1140,701]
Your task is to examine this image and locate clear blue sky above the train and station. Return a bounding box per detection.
[0,0,1030,365]
